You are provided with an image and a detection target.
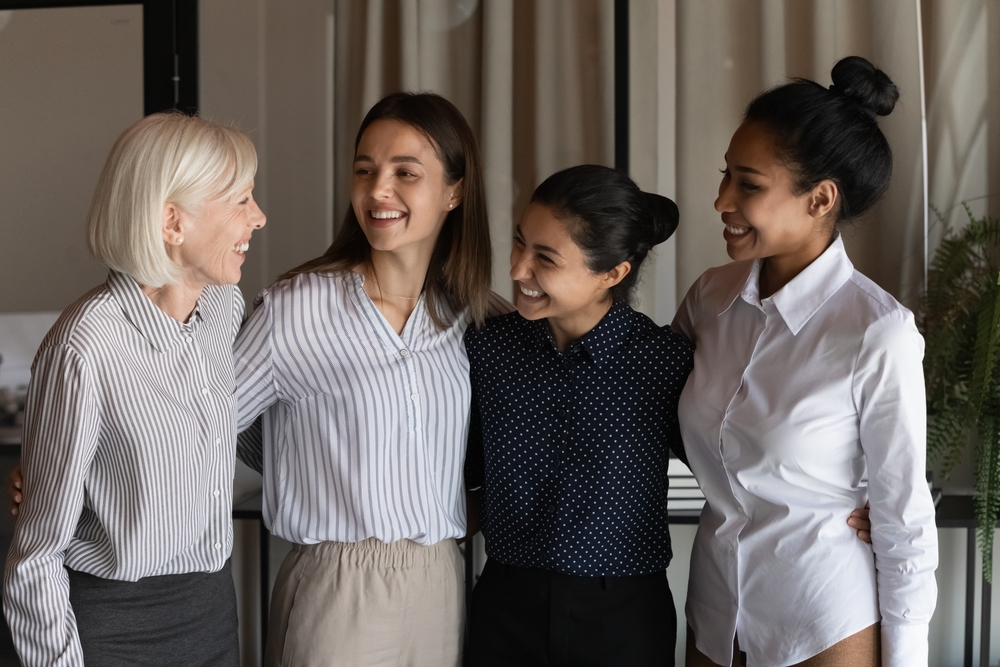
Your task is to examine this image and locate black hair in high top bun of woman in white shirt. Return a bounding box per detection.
[744,56,899,222]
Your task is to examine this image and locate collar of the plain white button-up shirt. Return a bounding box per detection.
[719,234,854,336]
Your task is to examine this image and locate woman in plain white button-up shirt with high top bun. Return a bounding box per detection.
[674,57,937,667]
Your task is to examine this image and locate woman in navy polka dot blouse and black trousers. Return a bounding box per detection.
[465,165,691,667]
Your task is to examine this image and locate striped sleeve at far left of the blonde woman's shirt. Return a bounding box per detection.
[4,345,99,667]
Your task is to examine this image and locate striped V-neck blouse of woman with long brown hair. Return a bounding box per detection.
[235,272,494,545]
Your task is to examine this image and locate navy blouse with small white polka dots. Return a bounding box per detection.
[465,303,693,576]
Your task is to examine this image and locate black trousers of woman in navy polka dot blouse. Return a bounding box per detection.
[466,559,677,667]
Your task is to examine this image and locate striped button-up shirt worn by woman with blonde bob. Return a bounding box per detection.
[3,271,243,666]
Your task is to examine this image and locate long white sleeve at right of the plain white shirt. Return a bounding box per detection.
[853,310,937,667]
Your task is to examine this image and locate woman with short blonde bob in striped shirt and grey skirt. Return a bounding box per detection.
[4,114,265,667]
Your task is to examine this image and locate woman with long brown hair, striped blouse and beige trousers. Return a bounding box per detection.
[235,93,504,667]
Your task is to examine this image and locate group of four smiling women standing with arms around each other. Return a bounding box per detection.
[4,57,937,667]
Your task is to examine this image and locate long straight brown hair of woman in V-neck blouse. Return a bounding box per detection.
[280,92,493,328]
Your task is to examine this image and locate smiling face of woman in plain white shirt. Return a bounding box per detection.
[715,122,836,270]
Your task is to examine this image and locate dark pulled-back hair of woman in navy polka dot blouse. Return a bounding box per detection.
[531,164,679,303]
